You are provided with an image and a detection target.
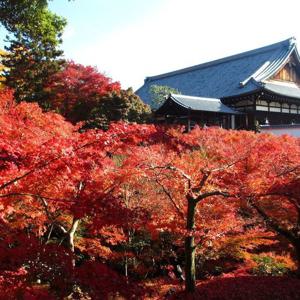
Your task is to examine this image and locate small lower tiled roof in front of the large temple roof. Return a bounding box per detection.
[157,94,240,114]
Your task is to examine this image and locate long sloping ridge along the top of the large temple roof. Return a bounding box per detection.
[145,37,296,83]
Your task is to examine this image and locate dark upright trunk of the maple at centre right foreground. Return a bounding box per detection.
[185,198,197,293]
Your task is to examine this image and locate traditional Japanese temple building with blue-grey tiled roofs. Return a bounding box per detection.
[136,38,300,129]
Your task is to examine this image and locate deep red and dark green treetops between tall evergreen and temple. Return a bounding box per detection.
[43,61,151,129]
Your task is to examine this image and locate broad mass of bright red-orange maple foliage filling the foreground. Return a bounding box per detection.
[0,88,300,299]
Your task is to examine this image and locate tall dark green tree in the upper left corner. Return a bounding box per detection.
[0,0,66,106]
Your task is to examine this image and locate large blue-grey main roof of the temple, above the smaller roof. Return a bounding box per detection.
[136,38,299,104]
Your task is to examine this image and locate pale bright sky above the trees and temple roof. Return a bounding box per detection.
[0,0,300,89]
